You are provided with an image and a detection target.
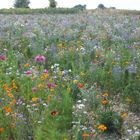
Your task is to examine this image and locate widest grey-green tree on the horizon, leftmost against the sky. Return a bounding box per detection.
[14,0,30,8]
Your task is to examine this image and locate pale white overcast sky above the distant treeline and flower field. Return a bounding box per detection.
[0,0,140,10]
